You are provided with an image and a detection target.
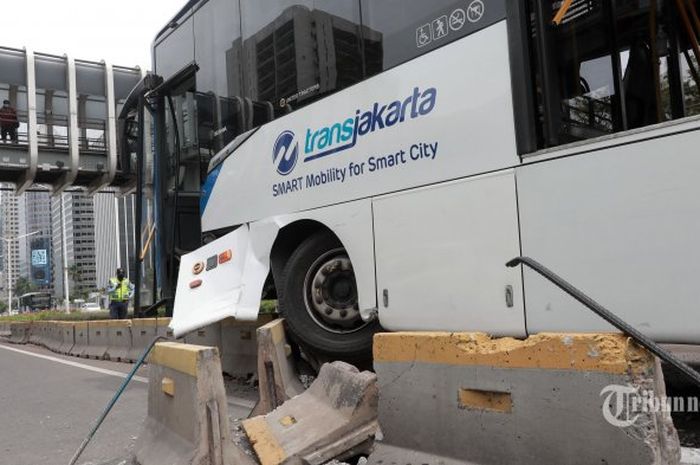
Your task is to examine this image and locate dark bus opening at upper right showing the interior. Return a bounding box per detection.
[530,0,700,147]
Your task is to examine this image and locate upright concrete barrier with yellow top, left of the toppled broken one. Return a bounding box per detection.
[136,342,254,465]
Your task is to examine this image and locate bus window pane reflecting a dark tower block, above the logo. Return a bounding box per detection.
[240,0,365,116]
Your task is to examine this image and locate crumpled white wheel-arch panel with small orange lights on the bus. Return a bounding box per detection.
[171,199,377,337]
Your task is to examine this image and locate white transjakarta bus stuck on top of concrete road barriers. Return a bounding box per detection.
[126,0,700,359]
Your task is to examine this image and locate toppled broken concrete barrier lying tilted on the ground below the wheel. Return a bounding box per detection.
[243,362,380,465]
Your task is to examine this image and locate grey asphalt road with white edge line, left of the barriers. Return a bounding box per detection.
[0,342,148,465]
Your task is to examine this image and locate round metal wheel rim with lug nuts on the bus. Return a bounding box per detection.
[304,248,367,334]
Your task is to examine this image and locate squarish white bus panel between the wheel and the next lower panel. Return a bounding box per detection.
[374,170,526,337]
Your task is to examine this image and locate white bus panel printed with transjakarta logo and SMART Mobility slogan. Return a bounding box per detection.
[202,21,519,231]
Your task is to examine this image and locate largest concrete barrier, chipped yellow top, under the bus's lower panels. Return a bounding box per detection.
[369,333,680,465]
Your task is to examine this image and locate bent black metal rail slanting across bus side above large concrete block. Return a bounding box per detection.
[506,257,700,387]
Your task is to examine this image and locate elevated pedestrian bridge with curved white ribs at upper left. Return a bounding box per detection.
[0,47,142,192]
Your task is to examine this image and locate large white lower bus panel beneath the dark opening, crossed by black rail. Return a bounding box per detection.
[517,125,700,343]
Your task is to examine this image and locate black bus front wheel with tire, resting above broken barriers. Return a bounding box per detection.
[278,231,380,363]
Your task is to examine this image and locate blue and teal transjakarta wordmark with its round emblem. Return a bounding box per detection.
[272,87,437,176]
